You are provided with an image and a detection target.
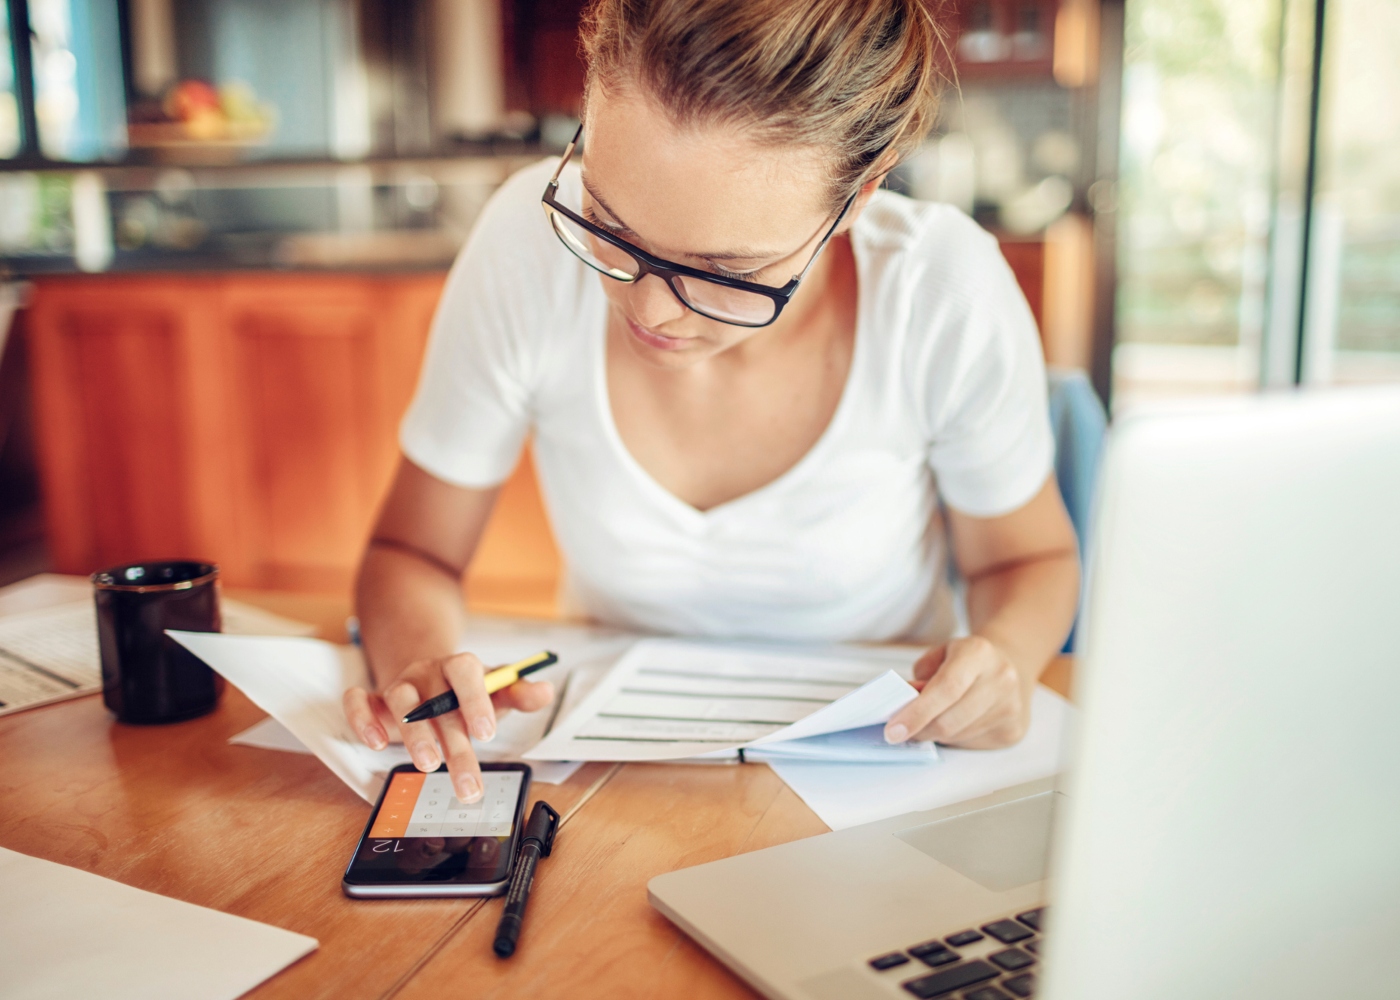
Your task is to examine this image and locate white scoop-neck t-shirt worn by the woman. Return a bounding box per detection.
[400,160,1053,643]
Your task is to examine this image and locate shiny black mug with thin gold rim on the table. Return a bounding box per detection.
[92,562,224,723]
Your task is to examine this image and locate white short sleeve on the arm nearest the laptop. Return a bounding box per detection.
[911,207,1054,517]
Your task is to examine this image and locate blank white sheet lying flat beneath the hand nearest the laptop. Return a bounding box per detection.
[769,688,1074,831]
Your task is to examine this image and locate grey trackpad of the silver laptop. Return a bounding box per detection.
[895,791,1060,892]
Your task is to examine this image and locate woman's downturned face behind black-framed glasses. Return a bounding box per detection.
[582,87,840,368]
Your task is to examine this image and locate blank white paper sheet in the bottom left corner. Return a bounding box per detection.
[0,847,318,1000]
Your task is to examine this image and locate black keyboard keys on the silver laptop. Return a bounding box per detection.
[869,906,1044,1000]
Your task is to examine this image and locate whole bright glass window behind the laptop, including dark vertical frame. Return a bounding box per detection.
[1113,0,1400,408]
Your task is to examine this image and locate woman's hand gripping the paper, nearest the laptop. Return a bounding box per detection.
[885,636,1035,749]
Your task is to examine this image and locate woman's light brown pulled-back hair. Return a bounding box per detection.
[581,0,946,204]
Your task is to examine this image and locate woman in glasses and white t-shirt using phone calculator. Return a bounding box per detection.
[346,0,1078,801]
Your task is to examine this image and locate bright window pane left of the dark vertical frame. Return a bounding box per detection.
[1113,0,1280,408]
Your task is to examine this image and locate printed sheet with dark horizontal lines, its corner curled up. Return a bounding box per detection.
[525,639,917,761]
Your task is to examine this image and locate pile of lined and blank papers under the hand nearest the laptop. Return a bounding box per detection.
[525,640,1072,829]
